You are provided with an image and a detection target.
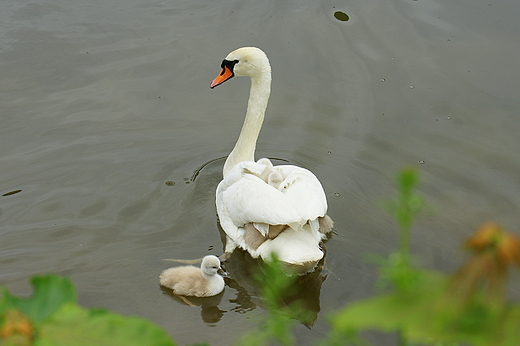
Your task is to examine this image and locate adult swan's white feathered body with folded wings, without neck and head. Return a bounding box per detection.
[217,159,333,267]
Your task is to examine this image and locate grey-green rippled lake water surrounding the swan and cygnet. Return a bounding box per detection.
[0,0,520,345]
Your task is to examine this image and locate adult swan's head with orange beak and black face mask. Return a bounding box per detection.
[210,47,271,89]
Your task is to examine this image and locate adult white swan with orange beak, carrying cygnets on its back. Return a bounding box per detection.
[210,47,333,269]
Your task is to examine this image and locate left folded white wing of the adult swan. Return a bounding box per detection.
[221,174,303,226]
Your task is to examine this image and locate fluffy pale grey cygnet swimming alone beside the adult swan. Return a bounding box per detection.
[159,255,224,297]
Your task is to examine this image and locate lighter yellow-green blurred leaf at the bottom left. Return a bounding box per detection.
[36,303,175,346]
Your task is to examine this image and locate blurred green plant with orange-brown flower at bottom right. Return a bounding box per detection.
[327,168,520,346]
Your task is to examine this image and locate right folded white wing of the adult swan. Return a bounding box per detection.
[275,166,327,220]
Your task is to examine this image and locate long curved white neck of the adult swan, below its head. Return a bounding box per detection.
[224,65,271,176]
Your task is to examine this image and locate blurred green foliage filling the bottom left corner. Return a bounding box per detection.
[0,275,175,346]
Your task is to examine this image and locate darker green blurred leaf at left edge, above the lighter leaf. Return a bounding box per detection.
[0,275,76,323]
